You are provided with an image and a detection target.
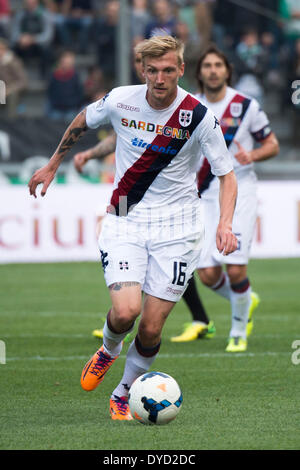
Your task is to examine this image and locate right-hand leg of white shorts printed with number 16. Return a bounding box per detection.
[143,231,203,302]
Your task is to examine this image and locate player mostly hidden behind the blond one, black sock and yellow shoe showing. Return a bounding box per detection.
[73,53,216,342]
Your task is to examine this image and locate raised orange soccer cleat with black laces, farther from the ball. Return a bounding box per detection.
[80,346,118,392]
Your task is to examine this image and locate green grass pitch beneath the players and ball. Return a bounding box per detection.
[0,259,300,450]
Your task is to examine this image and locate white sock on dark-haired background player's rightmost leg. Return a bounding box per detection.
[229,286,251,339]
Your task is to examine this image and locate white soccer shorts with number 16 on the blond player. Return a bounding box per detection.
[98,214,204,302]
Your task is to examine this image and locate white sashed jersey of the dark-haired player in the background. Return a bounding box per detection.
[196,87,271,197]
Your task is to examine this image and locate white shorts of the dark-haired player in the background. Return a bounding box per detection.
[197,188,257,269]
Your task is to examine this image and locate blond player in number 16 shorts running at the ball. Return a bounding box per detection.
[29,36,237,420]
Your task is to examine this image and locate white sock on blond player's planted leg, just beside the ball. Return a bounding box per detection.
[112,339,160,397]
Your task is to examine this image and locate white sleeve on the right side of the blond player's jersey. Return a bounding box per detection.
[199,110,233,176]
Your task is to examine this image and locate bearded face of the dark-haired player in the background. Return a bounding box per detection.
[199,54,228,92]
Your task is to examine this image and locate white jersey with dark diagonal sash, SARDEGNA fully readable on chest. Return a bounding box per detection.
[86,85,233,221]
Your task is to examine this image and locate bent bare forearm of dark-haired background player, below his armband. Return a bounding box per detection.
[234,132,279,165]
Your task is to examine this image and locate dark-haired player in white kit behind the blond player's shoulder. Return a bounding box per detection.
[174,46,279,352]
